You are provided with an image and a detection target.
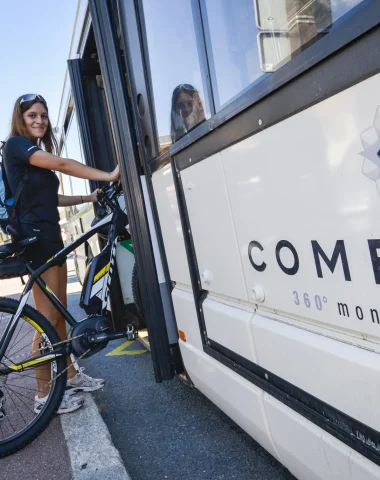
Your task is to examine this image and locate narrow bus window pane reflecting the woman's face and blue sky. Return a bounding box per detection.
[143,0,210,146]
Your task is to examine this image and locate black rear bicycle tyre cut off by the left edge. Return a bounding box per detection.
[0,297,67,458]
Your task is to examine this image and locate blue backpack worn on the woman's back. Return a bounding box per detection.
[0,142,28,240]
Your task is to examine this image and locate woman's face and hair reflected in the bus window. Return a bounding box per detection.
[170,83,206,143]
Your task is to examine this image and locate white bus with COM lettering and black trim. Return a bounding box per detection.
[58,0,380,480]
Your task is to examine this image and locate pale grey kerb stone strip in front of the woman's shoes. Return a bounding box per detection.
[60,394,131,480]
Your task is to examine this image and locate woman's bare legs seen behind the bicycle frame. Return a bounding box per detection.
[32,264,76,397]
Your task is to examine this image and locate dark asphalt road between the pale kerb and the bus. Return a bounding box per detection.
[70,295,294,480]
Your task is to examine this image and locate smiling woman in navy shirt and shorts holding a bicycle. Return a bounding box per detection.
[3,94,120,413]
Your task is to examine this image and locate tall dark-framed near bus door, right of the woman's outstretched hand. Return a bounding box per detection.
[89,0,177,382]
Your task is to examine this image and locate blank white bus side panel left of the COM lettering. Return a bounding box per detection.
[181,153,248,301]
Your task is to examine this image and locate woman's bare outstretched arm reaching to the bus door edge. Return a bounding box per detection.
[29,150,120,182]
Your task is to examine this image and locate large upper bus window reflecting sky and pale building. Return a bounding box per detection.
[201,0,362,110]
